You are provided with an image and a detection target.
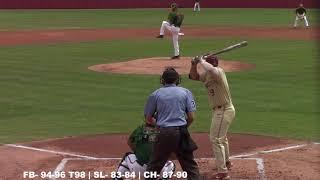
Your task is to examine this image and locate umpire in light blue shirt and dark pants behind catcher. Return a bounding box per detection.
[144,67,199,180]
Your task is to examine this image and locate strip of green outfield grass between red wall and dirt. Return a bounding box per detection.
[0,8,319,30]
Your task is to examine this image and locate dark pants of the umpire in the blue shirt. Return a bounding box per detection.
[147,127,199,180]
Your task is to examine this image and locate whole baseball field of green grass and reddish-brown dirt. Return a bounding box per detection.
[0,9,320,180]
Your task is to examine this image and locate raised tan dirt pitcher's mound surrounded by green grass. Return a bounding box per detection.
[88,57,255,74]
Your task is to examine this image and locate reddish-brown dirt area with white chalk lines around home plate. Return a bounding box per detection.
[0,133,320,180]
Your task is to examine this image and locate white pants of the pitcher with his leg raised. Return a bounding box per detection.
[160,21,180,56]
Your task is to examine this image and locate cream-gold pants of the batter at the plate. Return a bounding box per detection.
[210,105,235,173]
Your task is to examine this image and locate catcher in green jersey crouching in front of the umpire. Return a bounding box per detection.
[115,121,175,180]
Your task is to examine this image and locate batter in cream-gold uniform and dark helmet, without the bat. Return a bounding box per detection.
[189,56,235,179]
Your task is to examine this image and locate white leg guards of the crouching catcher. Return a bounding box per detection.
[117,153,175,177]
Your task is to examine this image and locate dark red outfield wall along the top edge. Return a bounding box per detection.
[0,0,320,9]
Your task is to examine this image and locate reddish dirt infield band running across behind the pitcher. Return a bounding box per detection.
[0,27,320,46]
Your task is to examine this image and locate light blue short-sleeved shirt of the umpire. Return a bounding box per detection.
[144,84,196,127]
